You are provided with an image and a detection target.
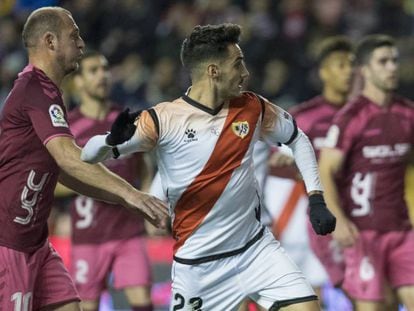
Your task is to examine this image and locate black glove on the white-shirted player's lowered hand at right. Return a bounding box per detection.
[309,193,336,235]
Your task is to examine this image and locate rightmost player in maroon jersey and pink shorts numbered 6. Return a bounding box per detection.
[320,35,414,310]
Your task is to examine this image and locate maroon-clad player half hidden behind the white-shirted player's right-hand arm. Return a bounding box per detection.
[290,36,353,292]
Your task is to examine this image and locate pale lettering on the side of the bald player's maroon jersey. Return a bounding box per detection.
[14,170,49,225]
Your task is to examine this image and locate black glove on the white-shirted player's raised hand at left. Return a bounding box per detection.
[106,108,142,146]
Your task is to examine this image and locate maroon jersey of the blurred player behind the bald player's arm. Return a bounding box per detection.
[68,108,144,244]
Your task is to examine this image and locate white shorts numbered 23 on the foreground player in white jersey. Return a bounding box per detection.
[170,229,317,311]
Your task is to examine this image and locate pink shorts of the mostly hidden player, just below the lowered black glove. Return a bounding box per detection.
[308,222,345,286]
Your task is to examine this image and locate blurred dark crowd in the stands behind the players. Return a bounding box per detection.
[0,0,414,109]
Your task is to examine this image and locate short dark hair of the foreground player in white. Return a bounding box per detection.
[181,23,241,72]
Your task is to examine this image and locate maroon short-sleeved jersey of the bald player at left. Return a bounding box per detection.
[0,65,72,252]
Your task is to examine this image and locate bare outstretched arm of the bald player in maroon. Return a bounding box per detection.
[46,137,168,228]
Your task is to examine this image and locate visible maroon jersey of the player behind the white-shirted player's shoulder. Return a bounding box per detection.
[289,96,341,158]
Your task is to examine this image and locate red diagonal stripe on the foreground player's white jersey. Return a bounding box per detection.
[173,93,261,253]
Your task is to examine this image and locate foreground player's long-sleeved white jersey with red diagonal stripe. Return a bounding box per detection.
[82,92,321,263]
